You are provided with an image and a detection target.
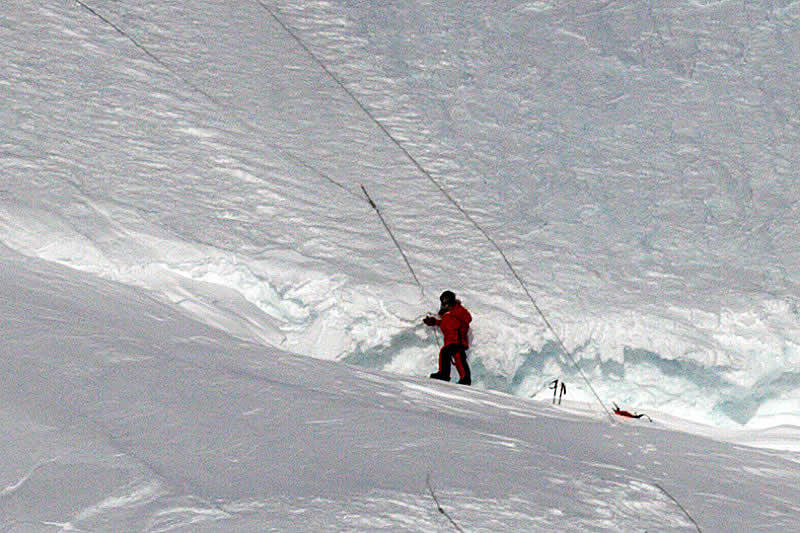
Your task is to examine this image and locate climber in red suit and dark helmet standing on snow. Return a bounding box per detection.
[423,291,472,385]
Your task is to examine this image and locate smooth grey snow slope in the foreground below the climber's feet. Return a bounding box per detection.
[0,248,800,532]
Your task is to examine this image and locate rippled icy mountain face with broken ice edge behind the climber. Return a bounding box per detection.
[0,0,800,426]
